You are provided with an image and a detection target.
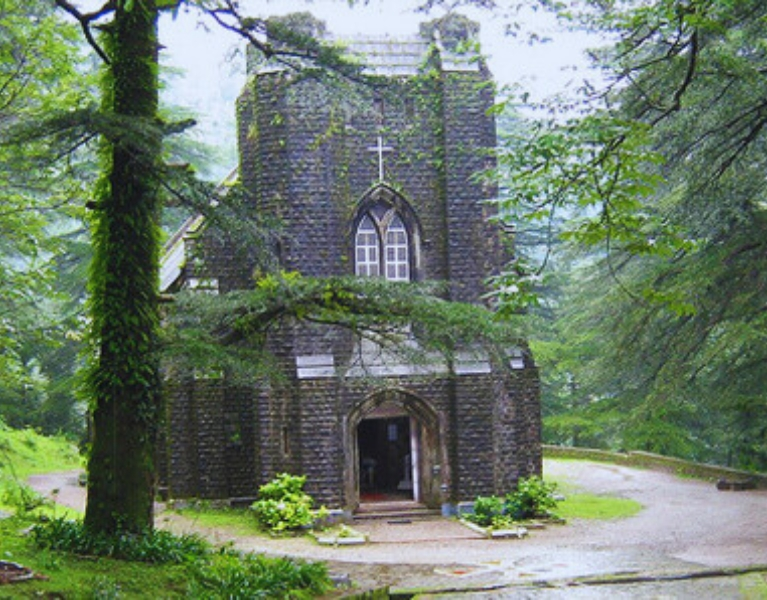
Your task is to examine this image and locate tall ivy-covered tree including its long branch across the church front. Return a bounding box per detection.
[51,0,532,533]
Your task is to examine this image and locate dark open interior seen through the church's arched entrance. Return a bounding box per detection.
[357,416,413,502]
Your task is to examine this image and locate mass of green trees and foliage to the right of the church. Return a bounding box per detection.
[498,0,767,469]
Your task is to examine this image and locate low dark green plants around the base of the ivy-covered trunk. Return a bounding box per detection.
[32,519,210,564]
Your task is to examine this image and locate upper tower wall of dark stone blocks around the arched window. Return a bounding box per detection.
[240,65,501,292]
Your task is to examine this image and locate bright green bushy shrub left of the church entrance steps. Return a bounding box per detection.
[250,473,316,533]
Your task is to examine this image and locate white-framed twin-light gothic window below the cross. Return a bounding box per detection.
[354,209,410,281]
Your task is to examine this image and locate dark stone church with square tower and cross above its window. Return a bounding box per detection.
[159,14,541,510]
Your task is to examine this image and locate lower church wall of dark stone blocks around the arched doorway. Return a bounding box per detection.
[165,360,541,506]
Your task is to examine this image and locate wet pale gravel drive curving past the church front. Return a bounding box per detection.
[30,460,767,599]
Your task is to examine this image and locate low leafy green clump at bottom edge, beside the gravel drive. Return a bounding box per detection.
[189,552,332,600]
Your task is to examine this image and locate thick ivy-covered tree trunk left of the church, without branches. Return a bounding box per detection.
[85,0,161,533]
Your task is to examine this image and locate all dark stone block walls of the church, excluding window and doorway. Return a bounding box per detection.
[161,15,541,507]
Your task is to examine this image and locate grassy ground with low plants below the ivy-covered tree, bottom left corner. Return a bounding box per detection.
[0,517,332,600]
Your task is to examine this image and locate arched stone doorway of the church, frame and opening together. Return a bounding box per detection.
[345,390,448,509]
